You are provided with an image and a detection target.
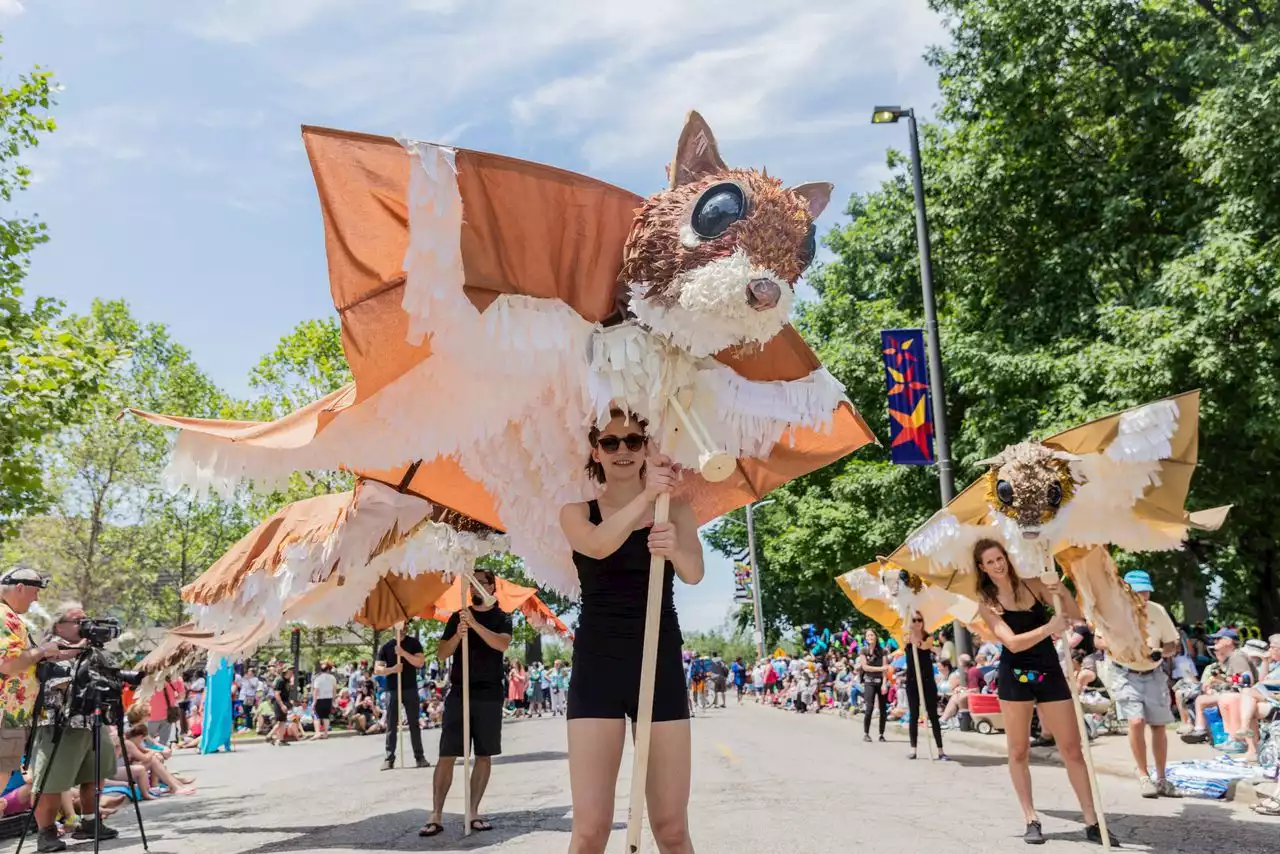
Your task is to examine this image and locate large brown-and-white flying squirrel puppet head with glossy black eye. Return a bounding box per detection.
[620,113,832,356]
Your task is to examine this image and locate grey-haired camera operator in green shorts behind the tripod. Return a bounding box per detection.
[32,602,120,851]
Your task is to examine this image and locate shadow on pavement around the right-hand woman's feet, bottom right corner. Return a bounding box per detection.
[1043,798,1280,854]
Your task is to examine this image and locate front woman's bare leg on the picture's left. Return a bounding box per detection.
[568,718,624,854]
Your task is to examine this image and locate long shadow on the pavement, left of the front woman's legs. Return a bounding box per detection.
[167,805,601,854]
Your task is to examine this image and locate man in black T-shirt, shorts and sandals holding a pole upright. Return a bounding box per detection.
[417,570,512,836]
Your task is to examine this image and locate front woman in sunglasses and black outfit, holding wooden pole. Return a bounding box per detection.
[561,410,703,854]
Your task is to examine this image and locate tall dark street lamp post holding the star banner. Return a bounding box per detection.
[872,106,972,656]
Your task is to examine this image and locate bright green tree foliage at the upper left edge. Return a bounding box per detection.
[0,45,114,540]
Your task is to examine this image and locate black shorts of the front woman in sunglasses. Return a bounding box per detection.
[564,631,689,723]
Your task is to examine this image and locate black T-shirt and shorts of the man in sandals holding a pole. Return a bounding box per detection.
[440,606,512,757]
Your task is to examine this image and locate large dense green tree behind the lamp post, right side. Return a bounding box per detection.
[709,0,1280,630]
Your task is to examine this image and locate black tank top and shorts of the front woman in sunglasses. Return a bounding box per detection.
[566,501,689,723]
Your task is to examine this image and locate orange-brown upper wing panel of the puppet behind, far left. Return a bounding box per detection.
[182,492,355,604]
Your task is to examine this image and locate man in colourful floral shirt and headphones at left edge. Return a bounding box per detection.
[0,567,76,780]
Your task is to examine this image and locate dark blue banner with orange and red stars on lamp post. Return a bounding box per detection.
[881,329,933,466]
